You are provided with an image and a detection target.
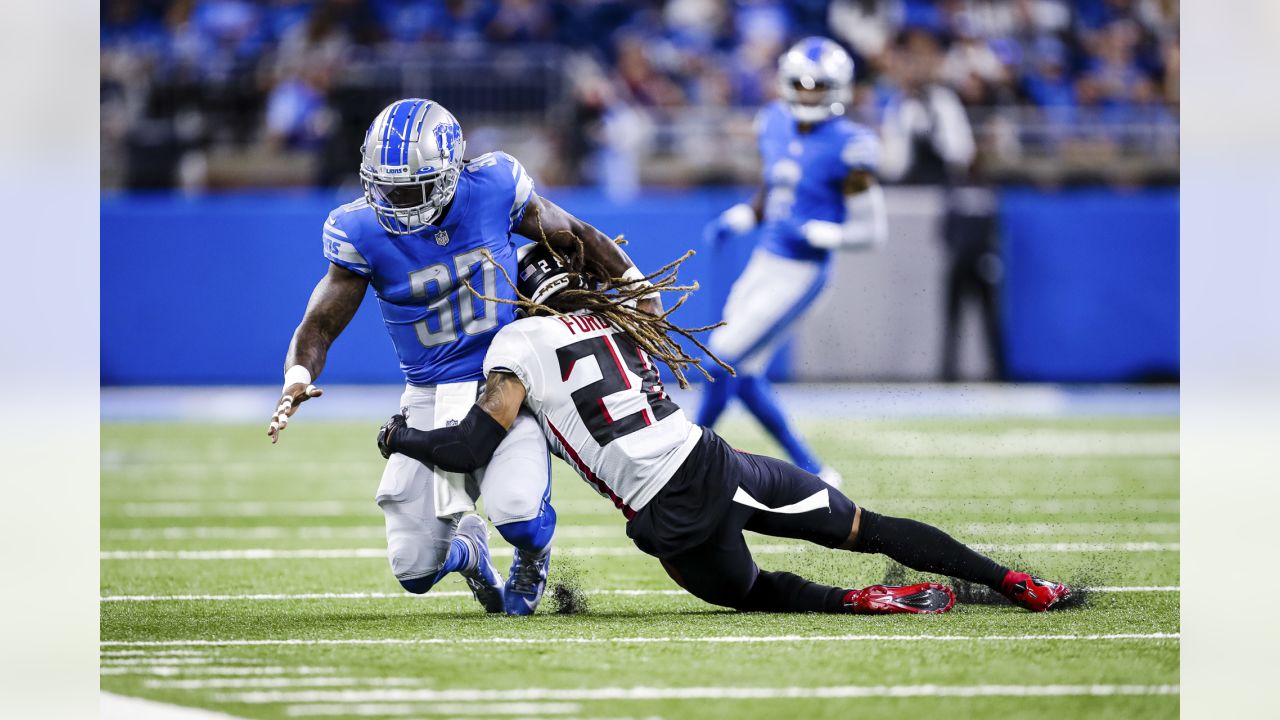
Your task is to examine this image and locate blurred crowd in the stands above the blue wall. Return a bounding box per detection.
[101,0,1179,195]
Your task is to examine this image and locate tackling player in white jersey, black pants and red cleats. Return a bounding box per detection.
[378,243,1070,612]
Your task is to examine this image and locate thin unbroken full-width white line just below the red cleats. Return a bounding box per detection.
[99,633,1181,647]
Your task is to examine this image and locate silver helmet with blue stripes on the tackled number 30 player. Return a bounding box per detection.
[360,97,467,234]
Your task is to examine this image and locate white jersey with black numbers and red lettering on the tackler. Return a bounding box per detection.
[484,313,703,520]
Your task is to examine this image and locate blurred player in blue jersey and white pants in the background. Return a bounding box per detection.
[698,37,888,487]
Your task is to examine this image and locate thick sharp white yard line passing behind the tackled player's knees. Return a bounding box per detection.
[99,542,1179,560]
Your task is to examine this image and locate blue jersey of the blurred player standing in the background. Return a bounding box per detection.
[755,102,879,260]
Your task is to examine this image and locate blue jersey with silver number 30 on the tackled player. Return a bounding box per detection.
[324,152,534,386]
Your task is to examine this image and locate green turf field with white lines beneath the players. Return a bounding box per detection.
[101,416,1180,720]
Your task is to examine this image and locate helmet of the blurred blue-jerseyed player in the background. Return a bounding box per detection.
[778,37,854,123]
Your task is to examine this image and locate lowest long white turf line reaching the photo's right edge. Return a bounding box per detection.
[218,684,1180,705]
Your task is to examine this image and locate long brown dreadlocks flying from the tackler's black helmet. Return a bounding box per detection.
[463,208,735,388]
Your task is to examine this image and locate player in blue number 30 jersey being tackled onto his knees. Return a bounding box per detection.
[268,99,660,615]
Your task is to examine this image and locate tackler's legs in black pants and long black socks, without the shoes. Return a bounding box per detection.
[662,452,1007,612]
